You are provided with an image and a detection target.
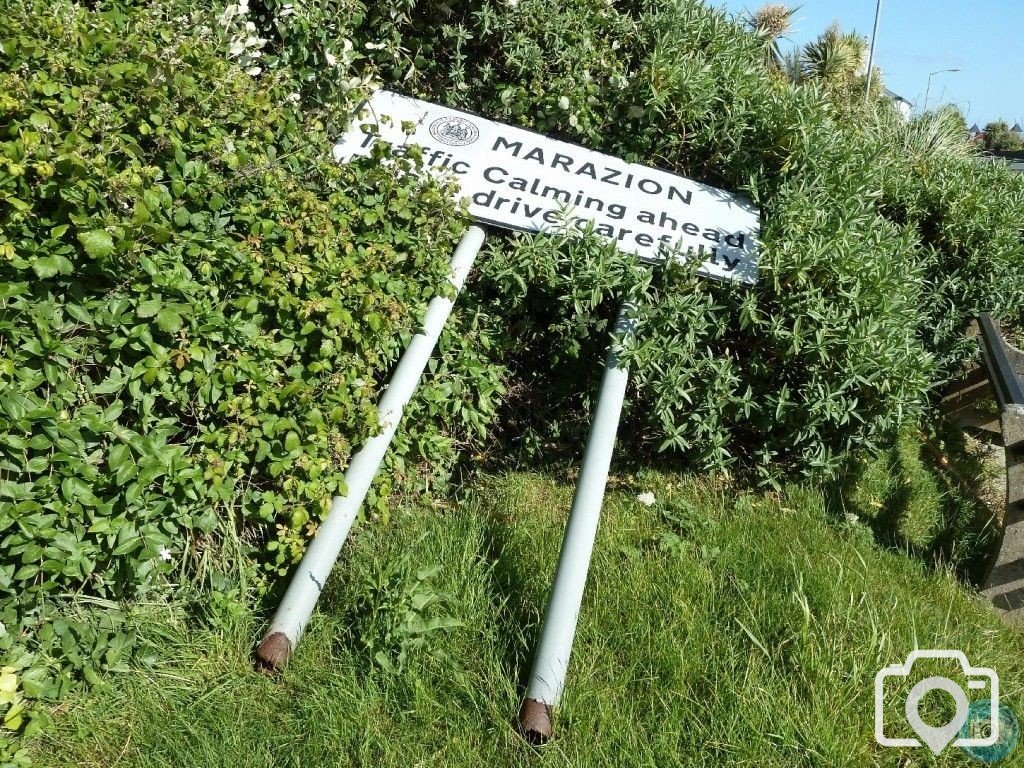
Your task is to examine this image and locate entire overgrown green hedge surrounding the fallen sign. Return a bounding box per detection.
[0,0,1024,761]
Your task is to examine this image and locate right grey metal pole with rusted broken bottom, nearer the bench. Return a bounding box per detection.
[519,303,634,743]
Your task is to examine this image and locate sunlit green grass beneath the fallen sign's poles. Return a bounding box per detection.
[32,473,1024,768]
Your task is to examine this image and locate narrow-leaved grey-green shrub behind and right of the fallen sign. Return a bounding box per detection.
[315,0,1024,480]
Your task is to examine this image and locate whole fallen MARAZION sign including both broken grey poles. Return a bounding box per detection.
[257,91,760,704]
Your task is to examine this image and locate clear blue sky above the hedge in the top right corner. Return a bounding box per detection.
[708,0,1024,128]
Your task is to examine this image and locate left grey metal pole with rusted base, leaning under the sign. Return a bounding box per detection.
[256,224,486,670]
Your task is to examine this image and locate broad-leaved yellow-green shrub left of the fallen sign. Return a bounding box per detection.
[0,0,501,729]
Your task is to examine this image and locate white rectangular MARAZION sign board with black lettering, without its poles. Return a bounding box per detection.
[334,90,761,283]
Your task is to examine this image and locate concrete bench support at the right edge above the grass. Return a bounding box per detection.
[982,403,1024,623]
